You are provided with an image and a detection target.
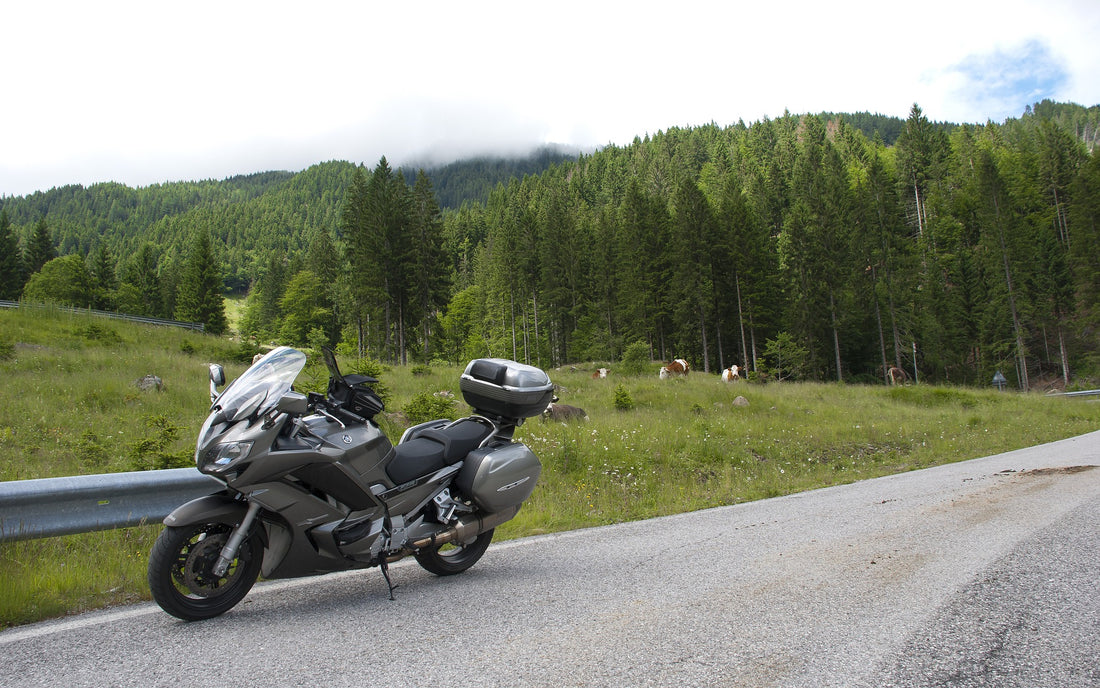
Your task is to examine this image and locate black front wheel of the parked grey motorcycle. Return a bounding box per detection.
[149,523,263,621]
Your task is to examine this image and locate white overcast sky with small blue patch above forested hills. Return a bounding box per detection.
[0,0,1100,196]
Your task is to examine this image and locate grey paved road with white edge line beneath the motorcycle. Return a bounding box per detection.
[0,433,1100,688]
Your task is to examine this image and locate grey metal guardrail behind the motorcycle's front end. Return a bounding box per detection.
[0,468,224,542]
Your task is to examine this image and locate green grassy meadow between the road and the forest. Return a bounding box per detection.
[0,310,1100,627]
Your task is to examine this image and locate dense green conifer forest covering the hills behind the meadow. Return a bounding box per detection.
[0,101,1100,391]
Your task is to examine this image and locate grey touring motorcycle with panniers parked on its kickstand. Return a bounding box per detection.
[149,347,553,621]
